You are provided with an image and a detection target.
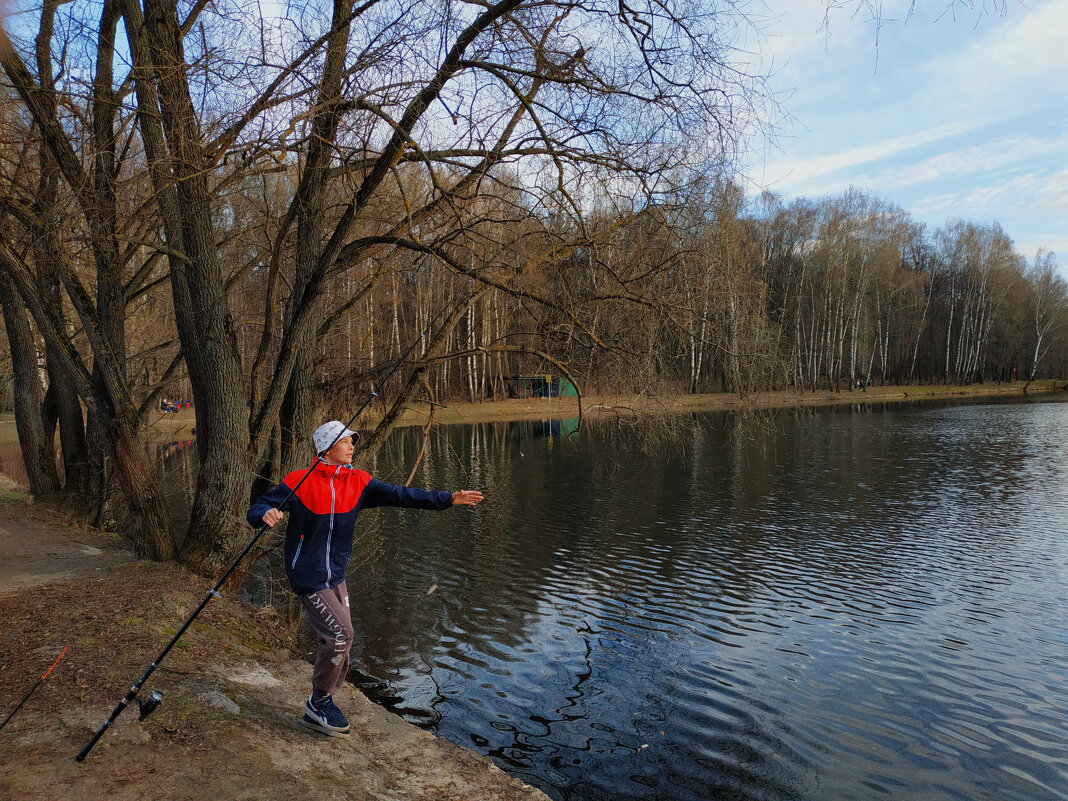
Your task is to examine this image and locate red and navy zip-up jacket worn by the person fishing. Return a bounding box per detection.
[246,461,453,595]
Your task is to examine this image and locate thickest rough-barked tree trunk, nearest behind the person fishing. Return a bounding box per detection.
[125,0,252,570]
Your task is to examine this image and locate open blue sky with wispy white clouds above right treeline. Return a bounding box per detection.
[745,0,1068,270]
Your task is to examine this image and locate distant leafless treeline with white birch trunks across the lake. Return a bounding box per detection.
[305,182,1068,401]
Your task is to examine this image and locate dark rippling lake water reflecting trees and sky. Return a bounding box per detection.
[350,403,1068,801]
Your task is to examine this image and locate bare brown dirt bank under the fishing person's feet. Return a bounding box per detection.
[0,500,546,801]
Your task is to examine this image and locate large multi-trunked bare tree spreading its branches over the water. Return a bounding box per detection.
[2,0,759,568]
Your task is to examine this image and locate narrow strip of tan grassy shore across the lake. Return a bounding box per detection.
[135,378,1068,439]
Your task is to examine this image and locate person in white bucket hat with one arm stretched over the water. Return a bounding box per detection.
[247,420,483,737]
